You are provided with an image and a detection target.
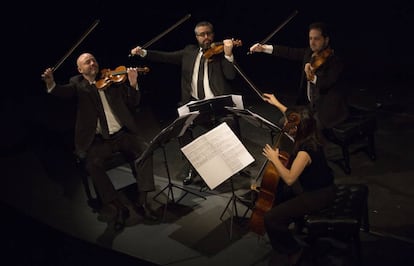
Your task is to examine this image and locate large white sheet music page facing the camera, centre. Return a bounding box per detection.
[181,122,254,189]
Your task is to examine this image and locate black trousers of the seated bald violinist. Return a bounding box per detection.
[85,132,155,204]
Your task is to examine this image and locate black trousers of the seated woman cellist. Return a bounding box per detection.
[264,186,335,255]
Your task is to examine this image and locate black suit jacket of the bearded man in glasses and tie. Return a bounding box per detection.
[145,44,236,105]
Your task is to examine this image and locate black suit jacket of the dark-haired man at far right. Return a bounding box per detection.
[273,45,348,128]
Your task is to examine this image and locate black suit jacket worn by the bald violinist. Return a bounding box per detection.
[51,75,141,153]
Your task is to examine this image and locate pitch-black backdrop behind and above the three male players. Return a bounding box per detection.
[4,0,414,152]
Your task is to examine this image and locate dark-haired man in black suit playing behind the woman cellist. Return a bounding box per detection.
[250,22,348,133]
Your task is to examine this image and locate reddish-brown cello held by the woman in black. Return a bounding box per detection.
[249,112,300,235]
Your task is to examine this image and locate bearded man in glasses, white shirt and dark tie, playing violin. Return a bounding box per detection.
[131,21,239,185]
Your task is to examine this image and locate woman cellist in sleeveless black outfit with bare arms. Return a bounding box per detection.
[263,93,335,265]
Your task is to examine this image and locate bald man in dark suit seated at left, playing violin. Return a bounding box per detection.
[42,53,156,230]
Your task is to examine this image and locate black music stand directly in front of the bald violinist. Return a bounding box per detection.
[135,113,207,215]
